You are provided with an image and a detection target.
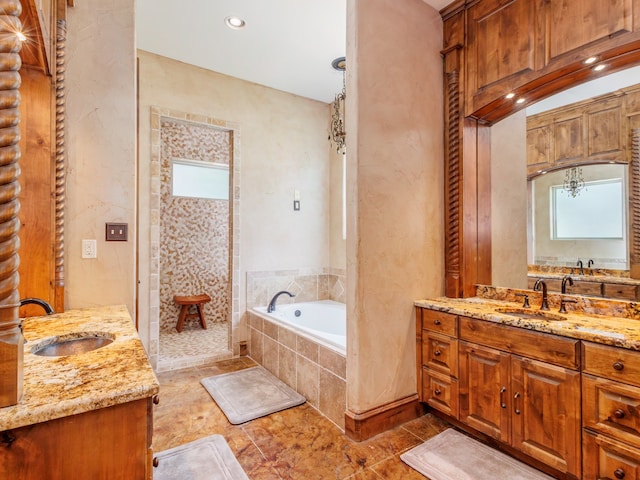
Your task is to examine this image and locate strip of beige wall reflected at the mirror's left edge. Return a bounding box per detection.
[491,110,527,288]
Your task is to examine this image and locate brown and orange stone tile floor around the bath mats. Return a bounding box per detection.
[153,357,449,480]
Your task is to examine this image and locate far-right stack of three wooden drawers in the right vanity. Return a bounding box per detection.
[582,342,640,480]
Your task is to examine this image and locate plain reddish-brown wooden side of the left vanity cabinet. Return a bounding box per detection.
[0,398,153,480]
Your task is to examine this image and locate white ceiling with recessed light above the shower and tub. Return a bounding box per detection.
[136,0,452,103]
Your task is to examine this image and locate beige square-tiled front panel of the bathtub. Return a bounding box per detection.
[248,313,346,431]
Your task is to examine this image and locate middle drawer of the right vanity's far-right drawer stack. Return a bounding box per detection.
[582,374,640,448]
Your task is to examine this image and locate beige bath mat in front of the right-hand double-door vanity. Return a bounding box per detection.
[400,428,553,480]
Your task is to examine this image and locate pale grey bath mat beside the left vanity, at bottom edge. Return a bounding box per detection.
[153,435,249,480]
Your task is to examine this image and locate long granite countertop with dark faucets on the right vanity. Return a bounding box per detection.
[415,297,640,350]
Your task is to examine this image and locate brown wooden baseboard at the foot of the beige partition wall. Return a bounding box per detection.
[344,393,425,442]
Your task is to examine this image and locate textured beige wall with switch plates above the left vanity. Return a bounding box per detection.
[65,0,136,313]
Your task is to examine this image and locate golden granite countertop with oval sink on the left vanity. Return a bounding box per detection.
[0,305,160,431]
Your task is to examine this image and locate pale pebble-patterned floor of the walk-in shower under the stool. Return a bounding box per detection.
[157,322,232,372]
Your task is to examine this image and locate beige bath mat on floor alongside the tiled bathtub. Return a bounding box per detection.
[200,366,306,425]
